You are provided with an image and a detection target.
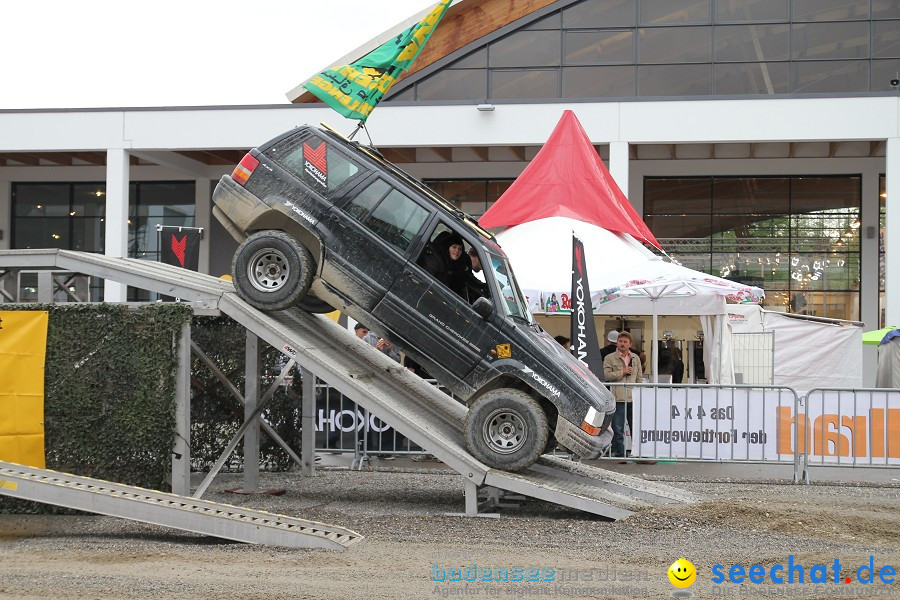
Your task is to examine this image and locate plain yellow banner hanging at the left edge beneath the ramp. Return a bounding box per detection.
[0,310,47,468]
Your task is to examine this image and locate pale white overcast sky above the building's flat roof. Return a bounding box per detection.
[0,0,437,109]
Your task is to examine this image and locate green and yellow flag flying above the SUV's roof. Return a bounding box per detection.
[304,0,451,123]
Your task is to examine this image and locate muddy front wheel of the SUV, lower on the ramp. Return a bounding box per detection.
[466,388,550,471]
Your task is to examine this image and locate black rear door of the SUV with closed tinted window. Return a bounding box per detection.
[320,176,431,312]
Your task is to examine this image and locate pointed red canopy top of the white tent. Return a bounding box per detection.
[478,110,662,249]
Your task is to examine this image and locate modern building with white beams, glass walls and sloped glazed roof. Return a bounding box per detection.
[0,0,900,380]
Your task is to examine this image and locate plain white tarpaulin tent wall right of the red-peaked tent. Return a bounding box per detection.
[728,304,863,394]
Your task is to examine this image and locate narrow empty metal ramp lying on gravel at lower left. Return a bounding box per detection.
[0,462,363,550]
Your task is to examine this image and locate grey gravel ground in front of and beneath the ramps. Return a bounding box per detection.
[0,463,900,599]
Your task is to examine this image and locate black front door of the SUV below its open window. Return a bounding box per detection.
[374,220,499,380]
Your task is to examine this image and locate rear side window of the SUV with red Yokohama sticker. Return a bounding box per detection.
[267,136,360,195]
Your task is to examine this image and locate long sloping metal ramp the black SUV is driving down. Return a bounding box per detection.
[0,250,694,519]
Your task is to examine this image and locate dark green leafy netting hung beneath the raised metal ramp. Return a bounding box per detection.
[0,303,301,510]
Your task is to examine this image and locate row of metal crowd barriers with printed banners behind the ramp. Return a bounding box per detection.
[316,381,900,483]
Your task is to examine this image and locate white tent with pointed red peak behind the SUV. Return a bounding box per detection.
[478,110,762,383]
